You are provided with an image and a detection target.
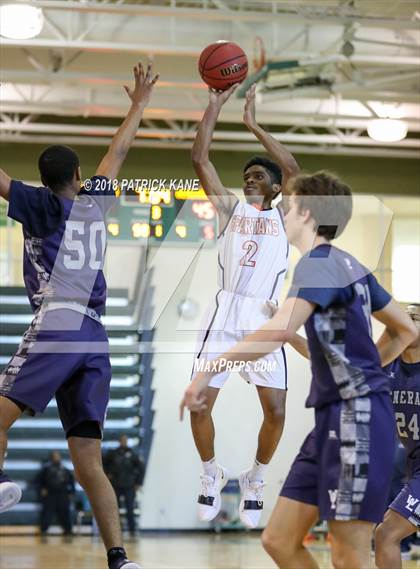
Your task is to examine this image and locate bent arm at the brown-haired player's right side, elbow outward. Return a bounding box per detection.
[373,300,418,366]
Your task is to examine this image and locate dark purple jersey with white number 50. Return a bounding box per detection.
[8,176,115,315]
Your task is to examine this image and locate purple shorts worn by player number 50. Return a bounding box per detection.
[0,309,111,432]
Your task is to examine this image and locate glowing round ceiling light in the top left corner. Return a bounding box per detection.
[0,4,44,40]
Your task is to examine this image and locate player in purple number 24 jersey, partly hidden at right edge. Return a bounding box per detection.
[375,304,420,569]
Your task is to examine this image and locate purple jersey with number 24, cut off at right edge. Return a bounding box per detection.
[384,358,420,470]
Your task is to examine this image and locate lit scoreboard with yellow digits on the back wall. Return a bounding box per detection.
[107,189,217,245]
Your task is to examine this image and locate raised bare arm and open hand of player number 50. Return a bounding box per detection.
[96,62,159,179]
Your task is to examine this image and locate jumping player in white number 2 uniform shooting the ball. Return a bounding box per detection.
[186,85,299,528]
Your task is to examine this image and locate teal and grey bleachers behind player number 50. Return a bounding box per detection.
[0,264,153,525]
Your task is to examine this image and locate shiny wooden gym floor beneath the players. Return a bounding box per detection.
[0,528,420,569]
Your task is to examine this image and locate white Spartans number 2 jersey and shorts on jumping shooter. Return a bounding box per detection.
[192,197,289,389]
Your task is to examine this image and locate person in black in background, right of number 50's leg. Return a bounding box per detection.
[104,435,144,535]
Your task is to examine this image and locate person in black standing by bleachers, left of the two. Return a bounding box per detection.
[37,451,74,535]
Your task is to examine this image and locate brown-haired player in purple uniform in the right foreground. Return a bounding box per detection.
[181,172,416,569]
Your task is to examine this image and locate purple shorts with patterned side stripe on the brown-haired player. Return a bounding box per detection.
[280,393,396,523]
